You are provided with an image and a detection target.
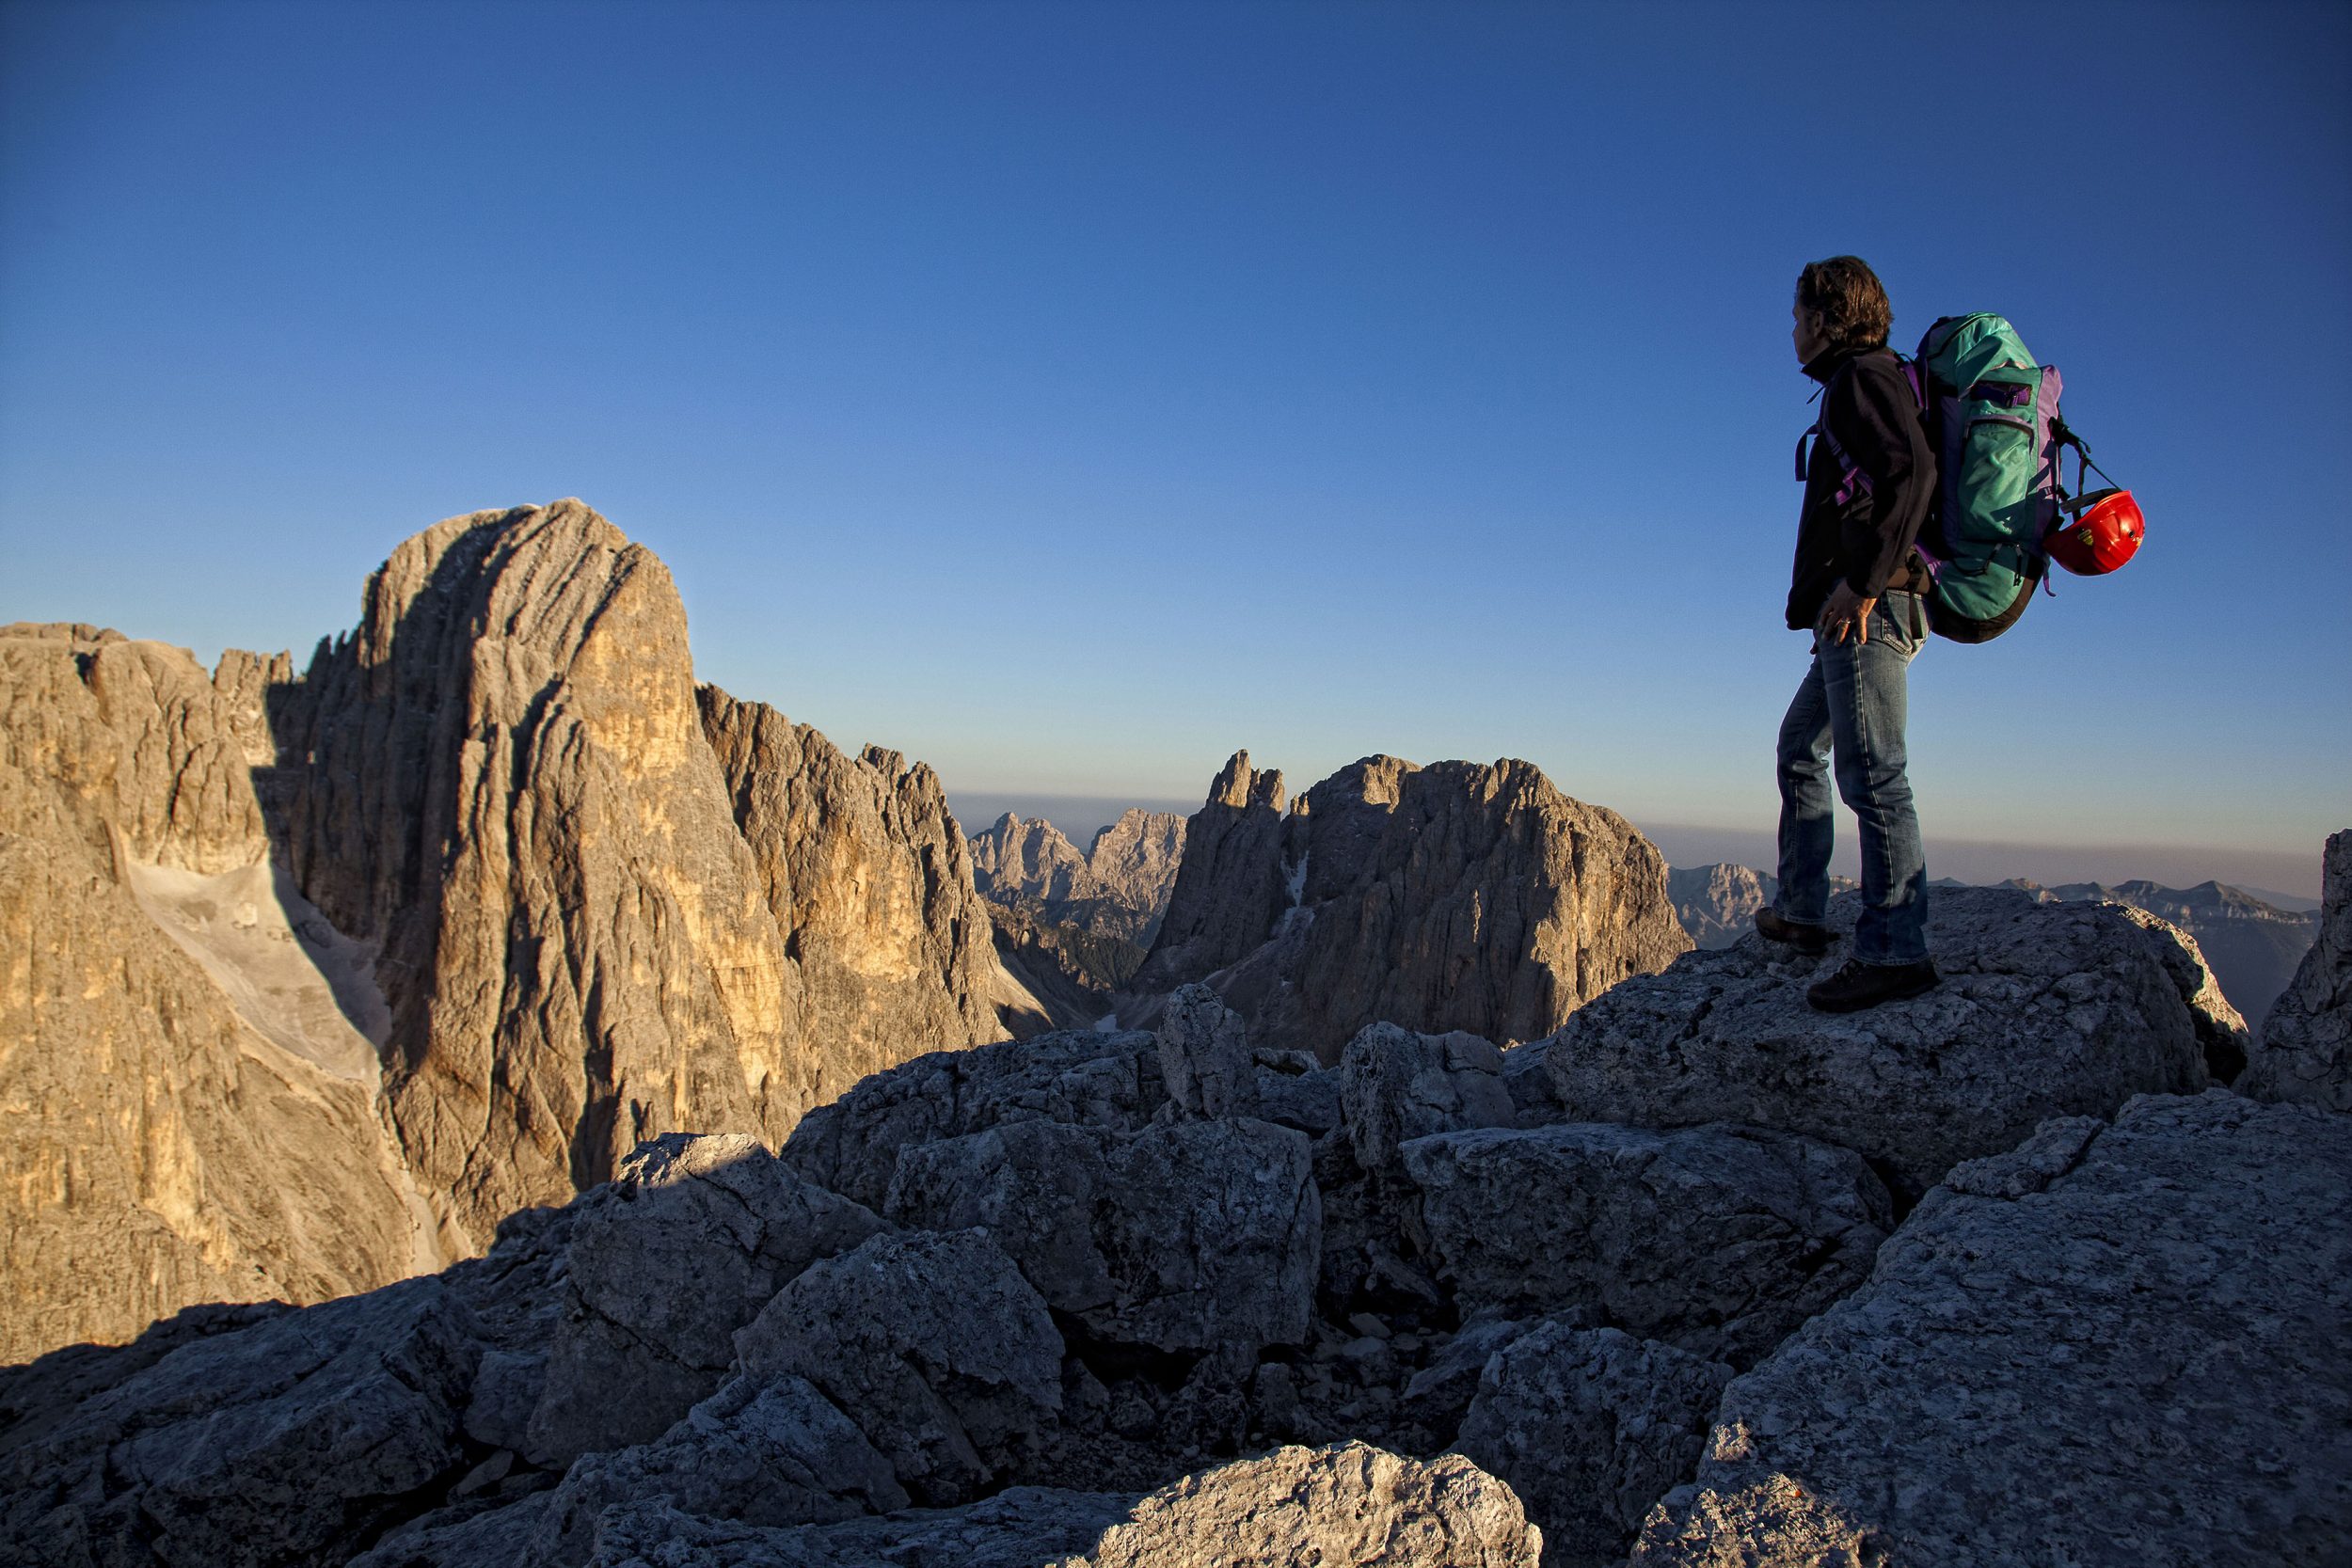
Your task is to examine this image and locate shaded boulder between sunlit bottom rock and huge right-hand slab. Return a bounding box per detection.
[1454,1323,1731,1568]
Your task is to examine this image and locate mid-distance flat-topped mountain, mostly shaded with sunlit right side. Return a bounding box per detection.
[1120,752,1692,1063]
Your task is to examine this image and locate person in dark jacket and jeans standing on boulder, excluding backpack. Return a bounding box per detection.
[1757,256,1936,1013]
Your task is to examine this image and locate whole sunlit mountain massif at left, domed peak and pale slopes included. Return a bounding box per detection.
[0,500,1011,1354]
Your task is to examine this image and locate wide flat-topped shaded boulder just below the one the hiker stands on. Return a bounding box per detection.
[1405,1121,1891,1366]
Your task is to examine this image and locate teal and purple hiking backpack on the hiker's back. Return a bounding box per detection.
[1905,312,2106,641]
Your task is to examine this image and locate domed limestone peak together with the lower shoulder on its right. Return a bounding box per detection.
[276,500,995,1251]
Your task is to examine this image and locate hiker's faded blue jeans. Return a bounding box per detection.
[1773,593,1927,964]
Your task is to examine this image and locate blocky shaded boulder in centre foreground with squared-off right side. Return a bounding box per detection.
[887,1119,1322,1354]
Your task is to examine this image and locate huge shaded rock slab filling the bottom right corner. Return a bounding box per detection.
[1632,1091,2352,1568]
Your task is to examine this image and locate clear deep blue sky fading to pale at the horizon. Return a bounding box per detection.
[0,0,2352,886]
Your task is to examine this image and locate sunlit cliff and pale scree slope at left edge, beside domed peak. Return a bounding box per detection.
[0,626,440,1361]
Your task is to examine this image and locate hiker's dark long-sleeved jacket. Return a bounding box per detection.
[1788,348,1936,632]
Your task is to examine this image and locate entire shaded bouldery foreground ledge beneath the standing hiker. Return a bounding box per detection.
[0,889,2352,1568]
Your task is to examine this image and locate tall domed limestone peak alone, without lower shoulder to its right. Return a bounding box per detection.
[278,503,812,1251]
